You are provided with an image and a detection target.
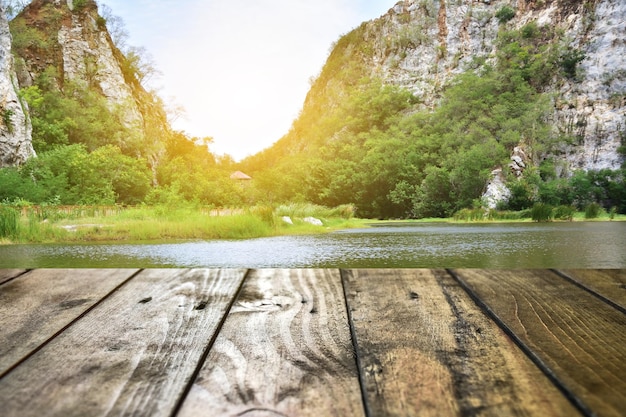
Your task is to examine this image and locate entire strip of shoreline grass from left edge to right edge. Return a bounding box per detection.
[0,204,626,244]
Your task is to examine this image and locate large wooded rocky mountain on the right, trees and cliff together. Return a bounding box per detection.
[243,0,626,217]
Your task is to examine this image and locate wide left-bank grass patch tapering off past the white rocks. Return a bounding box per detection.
[0,205,363,244]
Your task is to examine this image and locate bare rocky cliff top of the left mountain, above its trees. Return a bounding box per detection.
[11,0,169,167]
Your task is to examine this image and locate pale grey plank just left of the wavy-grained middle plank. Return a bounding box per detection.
[0,269,244,417]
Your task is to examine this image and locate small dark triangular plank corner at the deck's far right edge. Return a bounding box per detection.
[558,269,626,309]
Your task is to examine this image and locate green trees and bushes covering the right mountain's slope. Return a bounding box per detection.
[236,23,626,218]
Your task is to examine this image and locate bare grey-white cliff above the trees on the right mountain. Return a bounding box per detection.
[348,0,626,170]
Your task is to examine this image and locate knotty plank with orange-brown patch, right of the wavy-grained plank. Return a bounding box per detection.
[344,270,579,416]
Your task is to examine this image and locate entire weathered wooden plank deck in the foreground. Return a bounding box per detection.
[0,269,626,417]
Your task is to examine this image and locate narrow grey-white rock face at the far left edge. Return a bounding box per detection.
[0,6,35,168]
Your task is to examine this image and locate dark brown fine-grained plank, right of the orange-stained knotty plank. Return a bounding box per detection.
[456,270,626,417]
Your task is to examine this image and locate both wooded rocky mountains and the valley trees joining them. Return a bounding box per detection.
[0,0,626,214]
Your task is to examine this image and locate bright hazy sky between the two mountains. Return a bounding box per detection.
[98,0,397,160]
